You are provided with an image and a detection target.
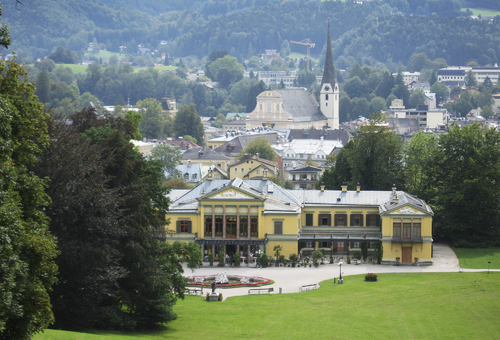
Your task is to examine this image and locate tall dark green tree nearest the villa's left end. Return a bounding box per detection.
[56,109,186,329]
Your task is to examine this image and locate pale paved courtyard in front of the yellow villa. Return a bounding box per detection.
[184,243,496,300]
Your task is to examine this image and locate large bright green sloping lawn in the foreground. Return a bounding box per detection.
[33,272,500,340]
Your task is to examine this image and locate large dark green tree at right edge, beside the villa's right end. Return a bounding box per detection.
[427,124,500,246]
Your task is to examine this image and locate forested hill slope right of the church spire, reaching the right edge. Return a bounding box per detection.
[333,16,500,65]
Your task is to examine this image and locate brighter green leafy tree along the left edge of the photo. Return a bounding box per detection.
[0,55,57,339]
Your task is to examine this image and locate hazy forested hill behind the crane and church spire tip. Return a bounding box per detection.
[177,1,392,58]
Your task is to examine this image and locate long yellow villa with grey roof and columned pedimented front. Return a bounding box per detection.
[167,174,433,265]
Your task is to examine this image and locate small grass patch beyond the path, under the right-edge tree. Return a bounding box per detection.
[453,248,500,269]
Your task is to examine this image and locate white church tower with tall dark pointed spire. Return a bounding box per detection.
[320,20,340,130]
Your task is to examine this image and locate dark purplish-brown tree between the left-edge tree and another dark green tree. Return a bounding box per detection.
[35,119,127,329]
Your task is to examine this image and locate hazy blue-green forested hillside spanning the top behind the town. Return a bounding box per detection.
[4,0,500,65]
